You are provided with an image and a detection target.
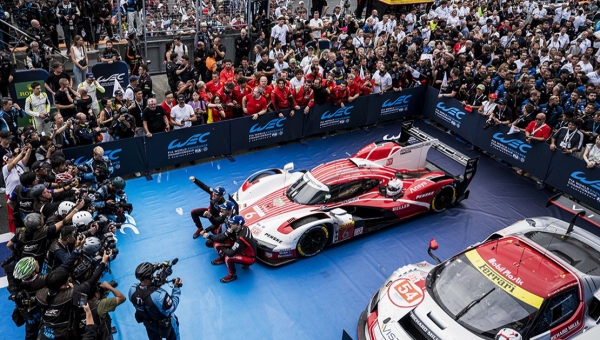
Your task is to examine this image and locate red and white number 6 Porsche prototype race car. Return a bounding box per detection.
[232,123,479,266]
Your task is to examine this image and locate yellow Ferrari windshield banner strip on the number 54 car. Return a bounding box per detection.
[465,249,544,309]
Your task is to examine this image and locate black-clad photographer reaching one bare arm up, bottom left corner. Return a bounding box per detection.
[36,247,110,340]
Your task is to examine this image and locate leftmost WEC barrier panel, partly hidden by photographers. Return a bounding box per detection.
[63,137,147,177]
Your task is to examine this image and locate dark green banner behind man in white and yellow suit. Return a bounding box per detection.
[8,69,54,126]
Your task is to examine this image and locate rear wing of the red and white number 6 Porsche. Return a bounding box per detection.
[397,121,479,202]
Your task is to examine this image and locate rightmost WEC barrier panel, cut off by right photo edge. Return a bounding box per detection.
[545,151,600,209]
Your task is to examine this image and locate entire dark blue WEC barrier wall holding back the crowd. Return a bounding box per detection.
[45,87,600,208]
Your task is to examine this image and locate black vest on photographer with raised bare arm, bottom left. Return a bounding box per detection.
[35,288,73,340]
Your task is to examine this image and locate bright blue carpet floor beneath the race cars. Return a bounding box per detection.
[0,123,598,340]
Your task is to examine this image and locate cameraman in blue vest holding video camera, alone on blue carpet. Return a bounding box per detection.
[129,262,182,340]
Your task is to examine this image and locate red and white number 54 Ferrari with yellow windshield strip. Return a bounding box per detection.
[358,216,600,340]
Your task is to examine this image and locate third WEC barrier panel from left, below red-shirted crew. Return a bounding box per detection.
[231,107,304,152]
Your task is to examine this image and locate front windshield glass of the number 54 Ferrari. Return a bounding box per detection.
[429,254,538,339]
